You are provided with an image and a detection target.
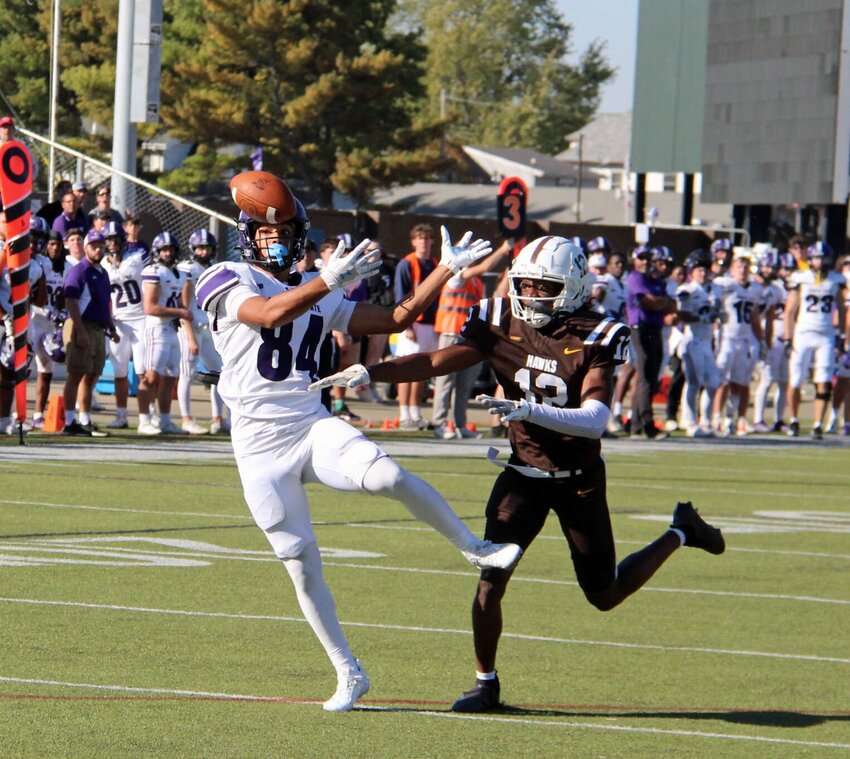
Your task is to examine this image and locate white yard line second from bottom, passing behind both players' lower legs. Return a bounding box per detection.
[0,598,850,664]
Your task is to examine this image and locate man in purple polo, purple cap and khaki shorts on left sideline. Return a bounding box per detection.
[62,232,120,437]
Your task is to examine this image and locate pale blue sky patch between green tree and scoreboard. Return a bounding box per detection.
[555,0,638,113]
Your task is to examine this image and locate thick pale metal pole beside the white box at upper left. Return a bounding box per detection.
[111,0,136,213]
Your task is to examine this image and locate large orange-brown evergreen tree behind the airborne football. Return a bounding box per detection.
[162,0,448,205]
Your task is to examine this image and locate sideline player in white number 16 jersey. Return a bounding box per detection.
[713,248,767,435]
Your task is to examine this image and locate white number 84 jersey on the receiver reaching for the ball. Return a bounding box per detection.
[195,262,355,455]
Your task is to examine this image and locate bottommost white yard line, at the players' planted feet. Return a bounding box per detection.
[0,676,850,749]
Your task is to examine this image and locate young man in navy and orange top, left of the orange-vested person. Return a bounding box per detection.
[394,224,437,430]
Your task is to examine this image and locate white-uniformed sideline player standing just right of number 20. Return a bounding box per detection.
[139,232,198,435]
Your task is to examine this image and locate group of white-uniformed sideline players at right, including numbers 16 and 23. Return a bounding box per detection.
[587,236,850,440]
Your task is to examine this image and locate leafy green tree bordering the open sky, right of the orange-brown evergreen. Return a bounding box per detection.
[399,0,614,153]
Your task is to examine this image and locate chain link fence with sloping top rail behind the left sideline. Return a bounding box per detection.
[16,128,239,260]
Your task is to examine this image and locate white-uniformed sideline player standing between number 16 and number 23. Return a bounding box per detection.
[753,247,794,432]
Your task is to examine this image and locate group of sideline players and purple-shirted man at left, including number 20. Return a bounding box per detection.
[0,205,230,437]
